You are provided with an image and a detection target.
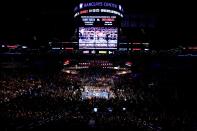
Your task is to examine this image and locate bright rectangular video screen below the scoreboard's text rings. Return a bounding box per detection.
[79,27,118,49]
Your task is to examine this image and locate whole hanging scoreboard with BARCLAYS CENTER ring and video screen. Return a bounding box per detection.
[74,2,124,51]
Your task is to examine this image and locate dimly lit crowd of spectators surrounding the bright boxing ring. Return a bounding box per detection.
[0,57,195,131]
